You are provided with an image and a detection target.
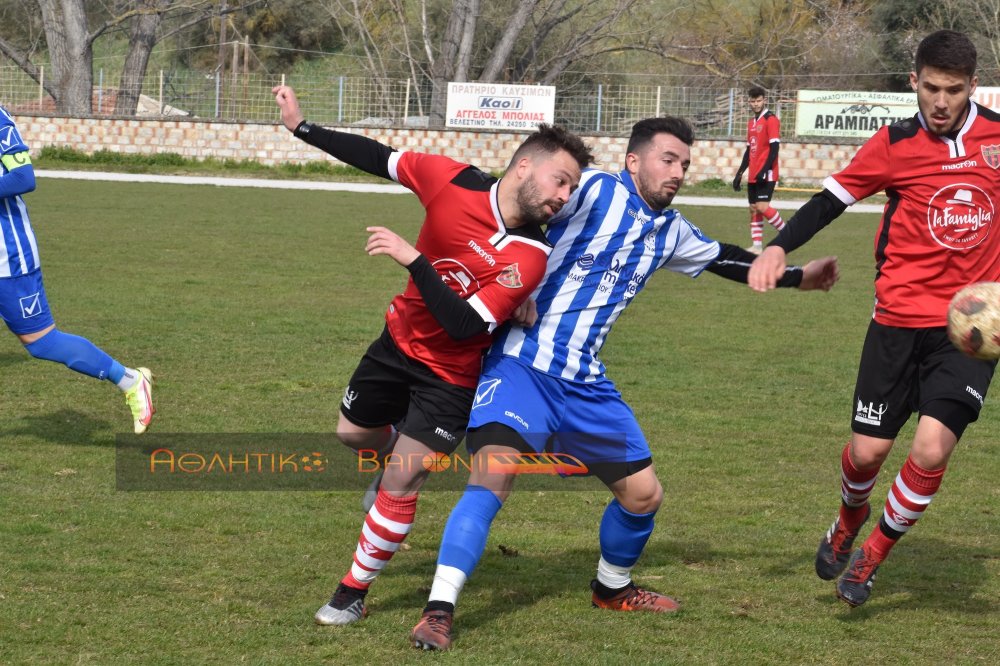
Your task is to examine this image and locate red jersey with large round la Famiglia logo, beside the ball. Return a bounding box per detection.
[823,102,1000,328]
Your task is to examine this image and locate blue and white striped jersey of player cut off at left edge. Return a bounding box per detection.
[0,106,41,278]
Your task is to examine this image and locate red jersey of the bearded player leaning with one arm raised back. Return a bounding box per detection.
[385,152,552,388]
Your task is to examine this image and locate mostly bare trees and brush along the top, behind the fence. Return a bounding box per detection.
[0,0,1000,124]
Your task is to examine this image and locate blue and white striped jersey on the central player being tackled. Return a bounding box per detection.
[490,169,720,382]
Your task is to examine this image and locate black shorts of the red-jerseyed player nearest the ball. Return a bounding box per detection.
[851,320,996,439]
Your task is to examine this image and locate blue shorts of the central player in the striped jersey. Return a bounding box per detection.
[467,355,652,466]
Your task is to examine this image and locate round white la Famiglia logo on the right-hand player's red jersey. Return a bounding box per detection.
[927,182,995,250]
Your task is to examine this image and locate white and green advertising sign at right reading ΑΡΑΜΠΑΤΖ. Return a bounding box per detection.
[795,90,917,139]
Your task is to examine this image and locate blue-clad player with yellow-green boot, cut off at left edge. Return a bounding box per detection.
[0,106,155,434]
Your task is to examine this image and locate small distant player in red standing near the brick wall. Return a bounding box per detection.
[733,86,785,254]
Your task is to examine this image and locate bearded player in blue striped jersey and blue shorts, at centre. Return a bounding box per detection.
[410,117,838,650]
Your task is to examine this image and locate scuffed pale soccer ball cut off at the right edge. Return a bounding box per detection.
[948,282,1000,360]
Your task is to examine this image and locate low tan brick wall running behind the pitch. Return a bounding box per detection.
[17,115,857,185]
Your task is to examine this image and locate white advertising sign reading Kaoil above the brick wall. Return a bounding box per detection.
[445,82,556,130]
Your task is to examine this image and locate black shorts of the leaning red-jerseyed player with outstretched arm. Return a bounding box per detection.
[340,329,476,454]
